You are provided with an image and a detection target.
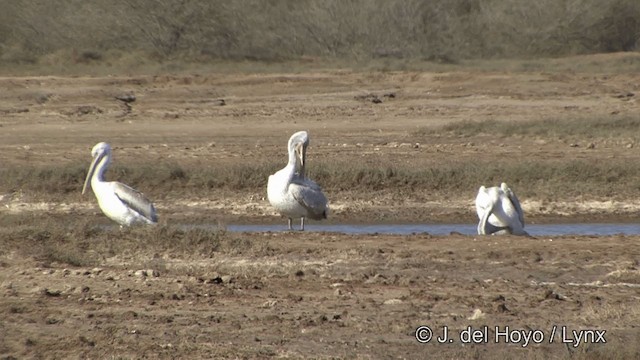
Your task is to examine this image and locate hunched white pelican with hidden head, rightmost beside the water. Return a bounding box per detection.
[476,183,529,235]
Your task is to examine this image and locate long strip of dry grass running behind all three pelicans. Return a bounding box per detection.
[0,155,640,204]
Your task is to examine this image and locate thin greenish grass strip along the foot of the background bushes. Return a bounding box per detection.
[0,52,640,76]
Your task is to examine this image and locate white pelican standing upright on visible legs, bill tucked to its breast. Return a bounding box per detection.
[267,131,329,230]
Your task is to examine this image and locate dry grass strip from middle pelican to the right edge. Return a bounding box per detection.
[310,160,640,200]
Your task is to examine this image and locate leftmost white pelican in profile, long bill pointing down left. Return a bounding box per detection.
[82,142,158,227]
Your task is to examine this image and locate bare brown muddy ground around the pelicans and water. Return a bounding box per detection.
[0,54,640,359]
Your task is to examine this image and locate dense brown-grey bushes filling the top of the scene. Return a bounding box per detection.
[0,0,640,65]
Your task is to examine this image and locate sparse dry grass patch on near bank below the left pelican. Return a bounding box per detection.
[0,215,271,270]
